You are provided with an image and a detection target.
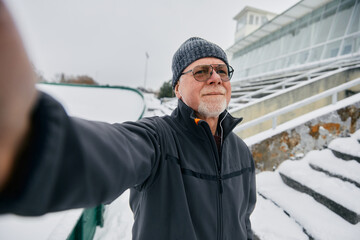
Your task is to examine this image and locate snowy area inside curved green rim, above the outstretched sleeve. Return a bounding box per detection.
[37,84,145,123]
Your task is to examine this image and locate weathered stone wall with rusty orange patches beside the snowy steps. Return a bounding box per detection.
[250,102,360,171]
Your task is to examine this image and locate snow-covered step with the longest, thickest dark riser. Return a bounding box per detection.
[278,156,360,224]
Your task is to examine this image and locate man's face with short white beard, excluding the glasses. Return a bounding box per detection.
[175,57,231,118]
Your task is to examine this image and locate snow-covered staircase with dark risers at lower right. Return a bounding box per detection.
[251,130,360,240]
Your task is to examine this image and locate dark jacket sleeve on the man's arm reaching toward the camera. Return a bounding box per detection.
[0,93,160,216]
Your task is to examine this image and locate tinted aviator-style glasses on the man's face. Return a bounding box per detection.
[181,64,234,82]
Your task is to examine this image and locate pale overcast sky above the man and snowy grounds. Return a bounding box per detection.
[5,0,298,89]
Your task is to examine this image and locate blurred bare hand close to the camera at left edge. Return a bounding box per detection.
[0,0,37,191]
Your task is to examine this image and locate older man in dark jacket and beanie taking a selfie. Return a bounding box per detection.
[0,1,256,240]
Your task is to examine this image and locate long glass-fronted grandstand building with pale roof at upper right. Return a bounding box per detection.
[227,0,360,83]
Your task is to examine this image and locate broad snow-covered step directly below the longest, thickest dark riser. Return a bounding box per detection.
[256,171,360,240]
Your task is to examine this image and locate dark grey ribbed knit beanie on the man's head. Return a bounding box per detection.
[172,37,229,89]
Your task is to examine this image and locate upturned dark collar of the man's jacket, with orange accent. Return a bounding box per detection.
[171,99,243,139]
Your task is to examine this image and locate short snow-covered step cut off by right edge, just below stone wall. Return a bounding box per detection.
[328,137,360,163]
